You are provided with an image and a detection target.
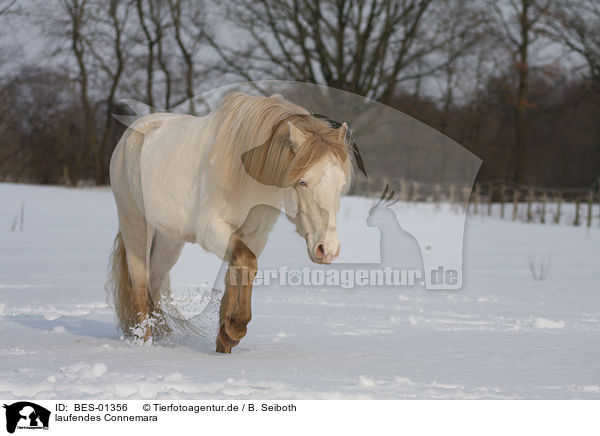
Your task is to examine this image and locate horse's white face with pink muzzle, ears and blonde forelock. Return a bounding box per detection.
[285,120,352,264]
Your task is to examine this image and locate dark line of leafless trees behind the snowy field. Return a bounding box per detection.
[0,0,600,188]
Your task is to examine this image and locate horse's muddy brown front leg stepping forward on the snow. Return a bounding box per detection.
[217,235,258,353]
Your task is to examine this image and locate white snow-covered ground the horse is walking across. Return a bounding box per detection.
[0,184,600,399]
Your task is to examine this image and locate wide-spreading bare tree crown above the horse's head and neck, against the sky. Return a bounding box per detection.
[209,0,447,101]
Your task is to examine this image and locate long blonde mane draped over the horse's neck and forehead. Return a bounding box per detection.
[209,93,352,199]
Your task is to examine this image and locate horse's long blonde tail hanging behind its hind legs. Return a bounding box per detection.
[106,232,137,335]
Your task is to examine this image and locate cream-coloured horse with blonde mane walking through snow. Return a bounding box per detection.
[110,93,352,353]
